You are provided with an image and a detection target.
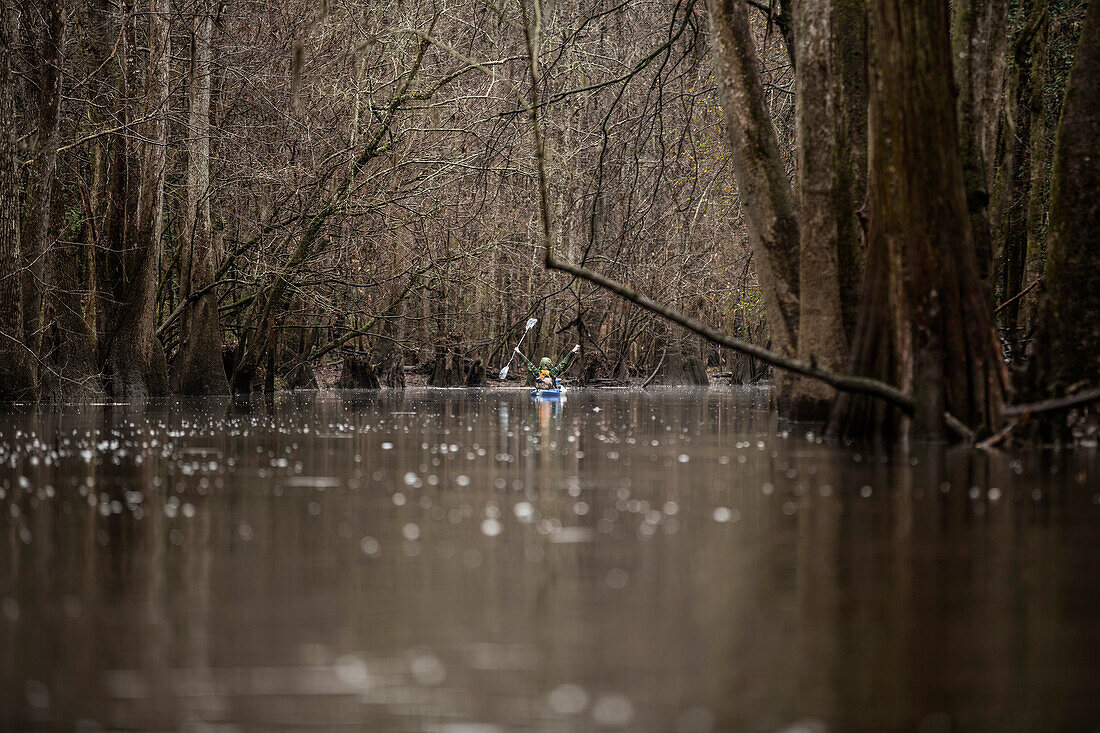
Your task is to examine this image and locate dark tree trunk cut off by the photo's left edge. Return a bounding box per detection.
[0,1,34,403]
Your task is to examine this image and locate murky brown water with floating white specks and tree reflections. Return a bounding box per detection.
[0,390,1100,733]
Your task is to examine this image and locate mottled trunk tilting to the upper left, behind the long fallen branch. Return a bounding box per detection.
[707,0,799,409]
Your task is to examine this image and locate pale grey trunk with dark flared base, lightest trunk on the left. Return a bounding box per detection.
[172,0,229,395]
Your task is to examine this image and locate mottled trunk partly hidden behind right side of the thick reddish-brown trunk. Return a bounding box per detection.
[952,0,1009,281]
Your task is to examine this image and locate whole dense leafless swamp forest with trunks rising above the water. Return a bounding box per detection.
[0,0,1100,436]
